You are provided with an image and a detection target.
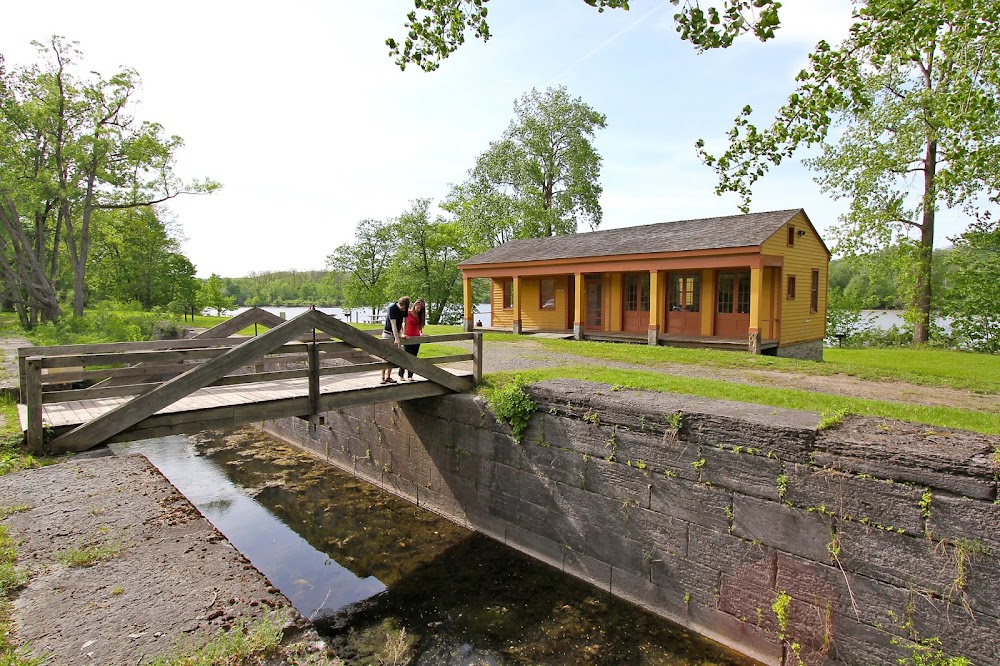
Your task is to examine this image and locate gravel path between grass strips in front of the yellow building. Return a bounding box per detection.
[483,340,1000,414]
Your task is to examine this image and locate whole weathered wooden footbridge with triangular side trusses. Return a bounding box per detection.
[18,308,482,454]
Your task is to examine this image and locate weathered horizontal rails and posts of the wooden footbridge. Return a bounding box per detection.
[18,331,483,452]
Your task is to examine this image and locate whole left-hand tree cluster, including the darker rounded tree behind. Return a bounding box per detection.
[0,37,218,327]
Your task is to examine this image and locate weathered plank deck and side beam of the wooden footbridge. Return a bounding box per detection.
[18,368,472,441]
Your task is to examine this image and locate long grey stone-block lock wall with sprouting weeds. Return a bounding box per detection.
[265,380,1000,666]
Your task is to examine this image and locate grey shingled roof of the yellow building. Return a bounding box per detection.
[459,208,808,266]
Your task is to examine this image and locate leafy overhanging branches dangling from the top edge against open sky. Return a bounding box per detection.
[385,0,781,72]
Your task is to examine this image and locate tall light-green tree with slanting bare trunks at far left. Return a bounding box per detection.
[0,37,218,319]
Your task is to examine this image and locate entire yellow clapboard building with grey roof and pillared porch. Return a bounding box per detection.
[459,209,830,360]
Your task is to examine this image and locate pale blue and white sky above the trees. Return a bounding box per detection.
[0,0,964,277]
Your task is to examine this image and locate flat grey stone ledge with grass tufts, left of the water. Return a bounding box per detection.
[0,456,326,665]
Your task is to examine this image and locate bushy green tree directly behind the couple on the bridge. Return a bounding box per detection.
[390,199,468,324]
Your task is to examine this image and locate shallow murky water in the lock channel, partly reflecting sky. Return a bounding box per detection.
[114,429,753,666]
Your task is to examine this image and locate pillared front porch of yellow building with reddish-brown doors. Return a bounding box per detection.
[464,253,783,353]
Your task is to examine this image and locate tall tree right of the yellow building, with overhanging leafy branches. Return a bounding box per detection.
[698,0,1000,344]
